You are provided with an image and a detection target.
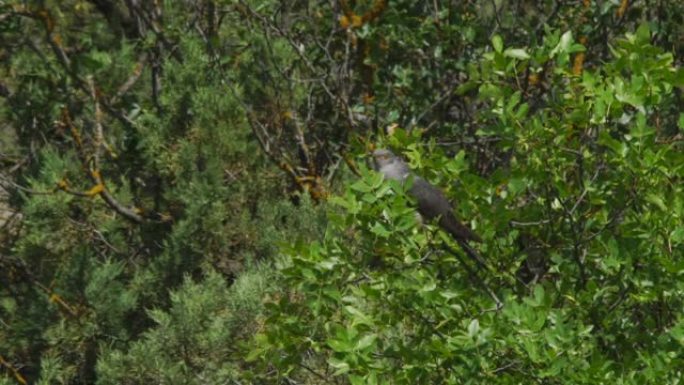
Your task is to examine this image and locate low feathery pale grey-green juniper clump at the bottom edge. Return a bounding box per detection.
[97,267,273,384]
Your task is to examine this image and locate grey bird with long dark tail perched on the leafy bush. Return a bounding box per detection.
[373,149,482,243]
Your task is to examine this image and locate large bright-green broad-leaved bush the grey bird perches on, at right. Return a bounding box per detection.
[251,26,684,384]
